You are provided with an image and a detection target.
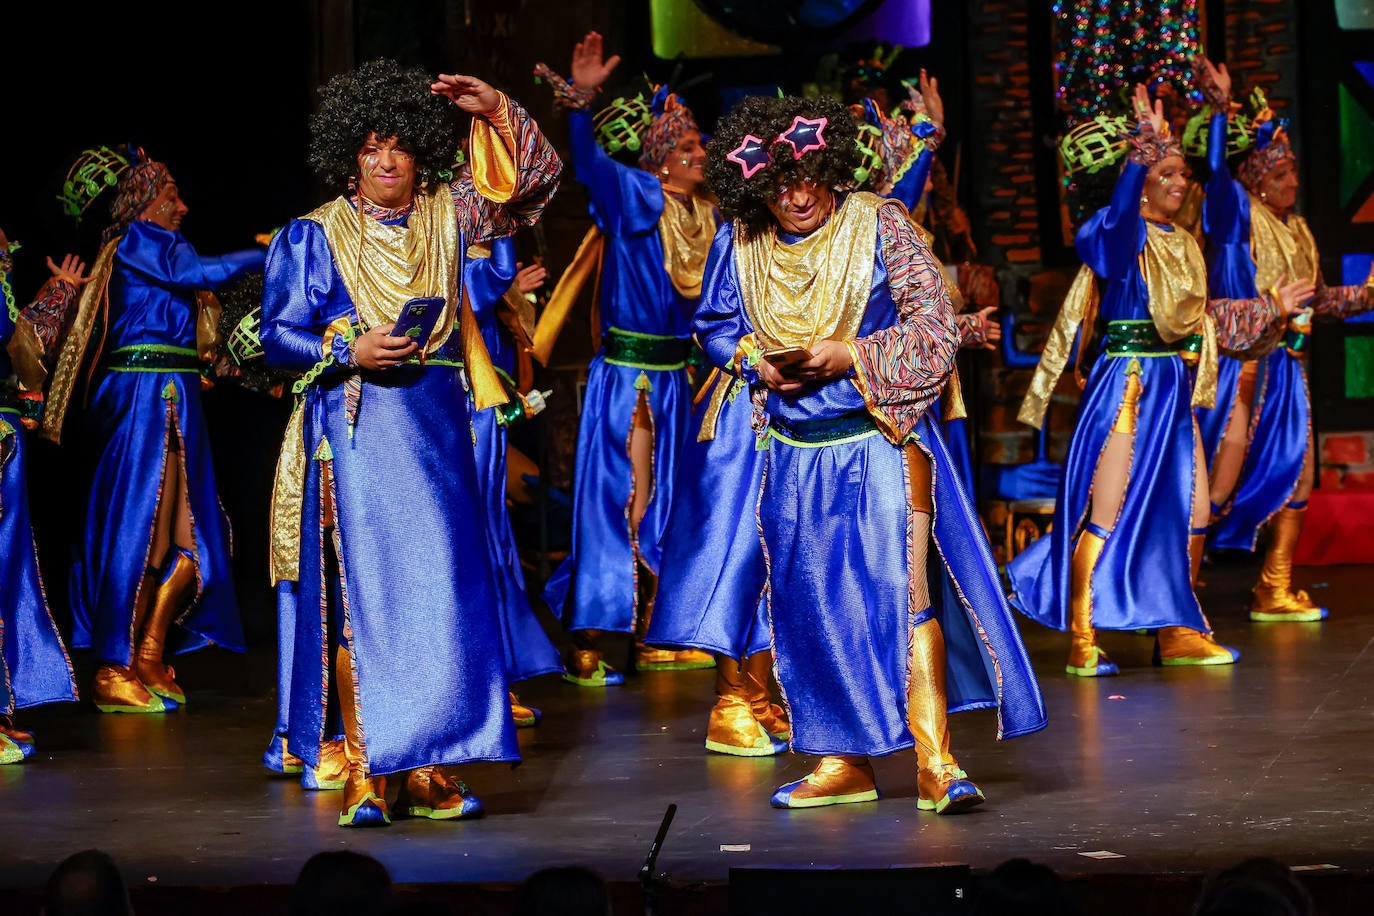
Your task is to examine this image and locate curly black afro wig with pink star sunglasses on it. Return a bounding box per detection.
[706,96,863,236]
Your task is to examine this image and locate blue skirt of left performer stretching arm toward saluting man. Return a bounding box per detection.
[70,372,243,665]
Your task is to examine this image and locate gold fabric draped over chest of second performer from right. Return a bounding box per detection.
[1140,222,1216,408]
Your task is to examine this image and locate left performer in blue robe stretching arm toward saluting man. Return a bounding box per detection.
[43,150,264,713]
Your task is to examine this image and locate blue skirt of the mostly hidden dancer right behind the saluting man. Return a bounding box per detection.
[469,397,563,681]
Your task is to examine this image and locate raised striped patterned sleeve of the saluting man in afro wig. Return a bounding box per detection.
[449,98,563,243]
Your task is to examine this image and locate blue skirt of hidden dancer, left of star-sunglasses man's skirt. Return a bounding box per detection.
[644,375,768,659]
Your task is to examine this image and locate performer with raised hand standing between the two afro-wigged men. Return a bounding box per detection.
[540,32,716,687]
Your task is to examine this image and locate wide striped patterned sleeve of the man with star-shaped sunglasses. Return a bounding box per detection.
[851,205,959,444]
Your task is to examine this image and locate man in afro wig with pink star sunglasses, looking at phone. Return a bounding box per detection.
[694,91,1046,813]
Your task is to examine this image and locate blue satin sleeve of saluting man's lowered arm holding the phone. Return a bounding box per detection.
[261,220,352,372]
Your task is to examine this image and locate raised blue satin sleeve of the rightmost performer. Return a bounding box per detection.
[1202,114,1259,299]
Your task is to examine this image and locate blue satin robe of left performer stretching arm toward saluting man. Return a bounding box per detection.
[71,220,264,665]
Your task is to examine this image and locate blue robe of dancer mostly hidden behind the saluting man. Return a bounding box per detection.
[464,236,563,681]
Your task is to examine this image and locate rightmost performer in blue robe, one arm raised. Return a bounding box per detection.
[1198,62,1374,622]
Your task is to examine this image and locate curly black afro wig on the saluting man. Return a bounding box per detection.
[311,58,459,190]
